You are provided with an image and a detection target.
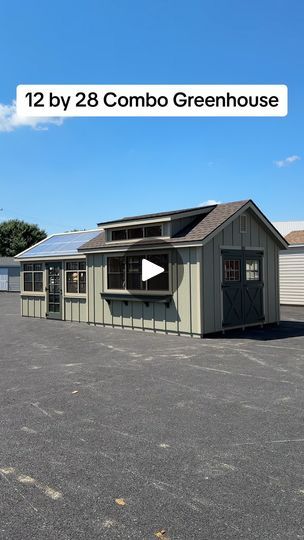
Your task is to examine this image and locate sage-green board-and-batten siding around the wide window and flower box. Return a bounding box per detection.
[87,248,201,335]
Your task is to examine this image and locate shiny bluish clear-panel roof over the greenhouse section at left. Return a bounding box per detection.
[22,230,100,258]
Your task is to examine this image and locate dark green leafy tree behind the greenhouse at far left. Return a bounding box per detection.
[0,219,46,257]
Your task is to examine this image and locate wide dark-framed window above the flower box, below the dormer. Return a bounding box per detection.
[107,253,169,291]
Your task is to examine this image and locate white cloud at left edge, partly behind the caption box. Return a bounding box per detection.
[0,101,63,132]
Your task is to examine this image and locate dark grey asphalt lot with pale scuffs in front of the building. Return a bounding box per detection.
[0,293,304,540]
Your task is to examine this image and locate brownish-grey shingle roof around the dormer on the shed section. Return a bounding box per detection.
[79,200,249,251]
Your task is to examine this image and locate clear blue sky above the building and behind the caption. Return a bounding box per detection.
[0,0,304,232]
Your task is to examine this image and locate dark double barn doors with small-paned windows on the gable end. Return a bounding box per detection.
[222,251,264,327]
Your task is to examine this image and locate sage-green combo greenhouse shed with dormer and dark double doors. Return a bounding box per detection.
[17,200,288,337]
